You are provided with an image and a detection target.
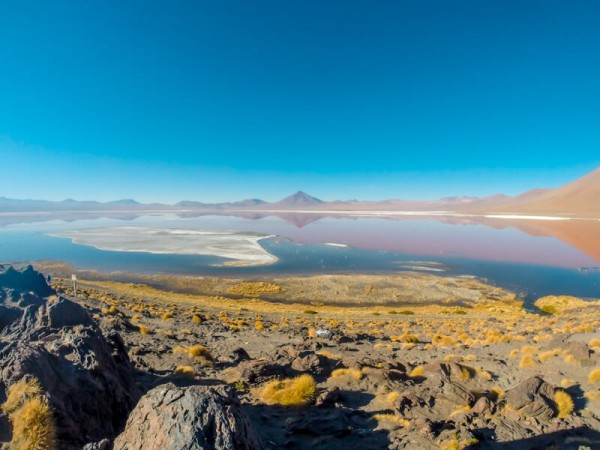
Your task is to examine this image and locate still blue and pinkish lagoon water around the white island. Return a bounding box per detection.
[0,215,600,299]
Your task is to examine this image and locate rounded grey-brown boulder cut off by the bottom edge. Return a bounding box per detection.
[114,383,262,450]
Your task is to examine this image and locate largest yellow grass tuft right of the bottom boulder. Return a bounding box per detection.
[259,374,317,406]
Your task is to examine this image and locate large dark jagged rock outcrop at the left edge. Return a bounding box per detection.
[0,265,140,449]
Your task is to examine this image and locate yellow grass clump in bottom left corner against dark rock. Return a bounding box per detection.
[2,379,56,450]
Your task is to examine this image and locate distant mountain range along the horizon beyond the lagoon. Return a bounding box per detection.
[0,168,600,218]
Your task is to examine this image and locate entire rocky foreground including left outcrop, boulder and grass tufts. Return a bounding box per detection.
[0,266,600,450]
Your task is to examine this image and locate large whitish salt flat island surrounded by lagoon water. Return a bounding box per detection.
[51,227,277,266]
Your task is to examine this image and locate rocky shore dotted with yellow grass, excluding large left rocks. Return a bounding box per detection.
[27,266,600,449]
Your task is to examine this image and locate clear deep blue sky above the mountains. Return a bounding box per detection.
[0,0,600,202]
